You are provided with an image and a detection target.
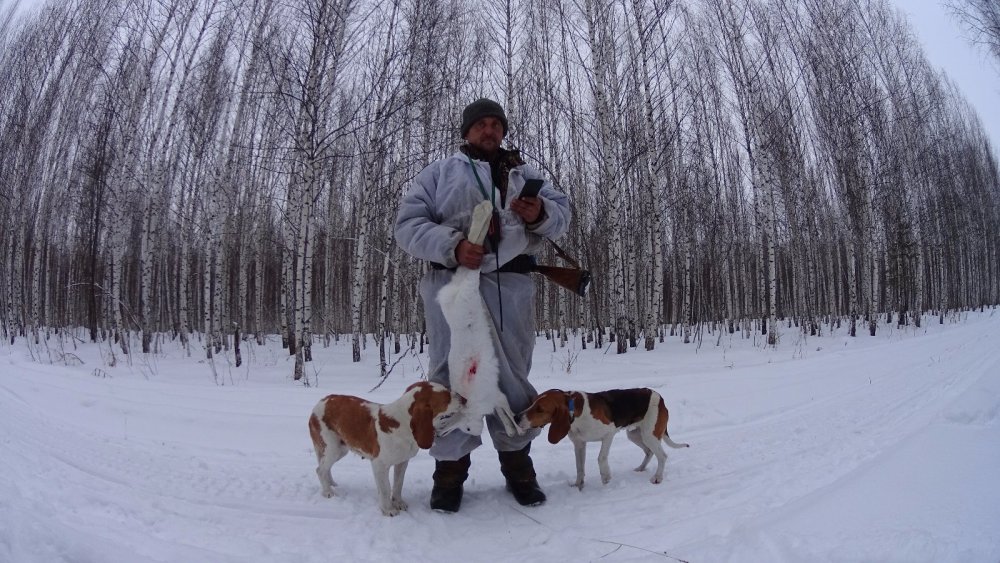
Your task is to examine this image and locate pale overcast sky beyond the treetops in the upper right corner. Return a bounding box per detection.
[7,0,1000,157]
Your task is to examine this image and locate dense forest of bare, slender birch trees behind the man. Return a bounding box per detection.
[0,0,1000,381]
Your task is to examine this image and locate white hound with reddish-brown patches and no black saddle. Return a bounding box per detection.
[309,381,463,516]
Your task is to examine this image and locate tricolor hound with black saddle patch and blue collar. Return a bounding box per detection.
[517,387,688,490]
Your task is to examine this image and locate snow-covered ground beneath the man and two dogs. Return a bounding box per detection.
[0,311,1000,563]
